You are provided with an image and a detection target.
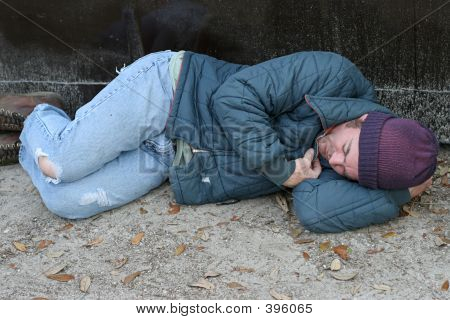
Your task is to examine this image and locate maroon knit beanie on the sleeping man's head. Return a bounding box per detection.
[358,112,439,189]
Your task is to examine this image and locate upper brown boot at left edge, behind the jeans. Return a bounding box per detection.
[0,92,65,131]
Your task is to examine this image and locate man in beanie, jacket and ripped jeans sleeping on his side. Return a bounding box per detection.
[0,51,438,232]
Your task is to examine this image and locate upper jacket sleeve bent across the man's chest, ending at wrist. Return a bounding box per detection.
[211,52,375,185]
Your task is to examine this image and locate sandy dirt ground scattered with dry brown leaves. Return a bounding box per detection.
[0,147,450,299]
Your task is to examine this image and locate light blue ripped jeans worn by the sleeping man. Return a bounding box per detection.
[19,51,174,219]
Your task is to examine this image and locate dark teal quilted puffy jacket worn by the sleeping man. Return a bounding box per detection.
[166,52,409,232]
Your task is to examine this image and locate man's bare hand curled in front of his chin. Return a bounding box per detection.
[283,148,322,188]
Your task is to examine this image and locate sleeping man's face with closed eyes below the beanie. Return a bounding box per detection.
[318,122,361,180]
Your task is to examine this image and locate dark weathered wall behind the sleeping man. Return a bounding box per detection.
[0,0,450,143]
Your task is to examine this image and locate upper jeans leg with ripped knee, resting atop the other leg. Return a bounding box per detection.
[20,51,173,183]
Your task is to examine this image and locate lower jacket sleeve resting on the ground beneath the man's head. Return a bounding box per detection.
[293,169,411,232]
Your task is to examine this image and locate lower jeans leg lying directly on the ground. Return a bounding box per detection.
[19,133,174,219]
